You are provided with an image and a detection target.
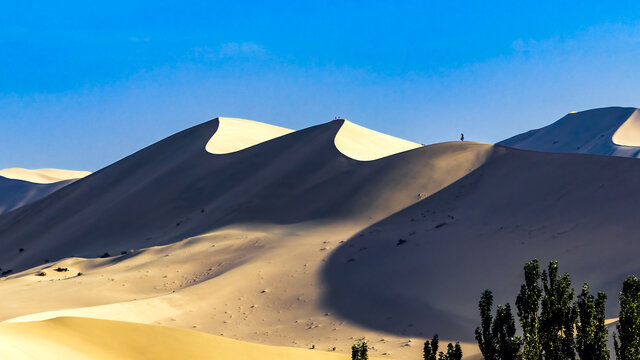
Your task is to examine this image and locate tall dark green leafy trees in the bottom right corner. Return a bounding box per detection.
[468,259,640,360]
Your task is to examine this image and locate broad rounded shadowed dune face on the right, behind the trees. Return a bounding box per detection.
[323,147,640,341]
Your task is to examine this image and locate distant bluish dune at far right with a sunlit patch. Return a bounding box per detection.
[499,107,640,158]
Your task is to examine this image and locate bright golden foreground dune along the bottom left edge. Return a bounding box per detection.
[0,317,382,360]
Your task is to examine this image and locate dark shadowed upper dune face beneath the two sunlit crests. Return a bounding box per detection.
[0,121,490,271]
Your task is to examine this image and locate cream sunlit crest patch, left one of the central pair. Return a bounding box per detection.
[205,117,293,155]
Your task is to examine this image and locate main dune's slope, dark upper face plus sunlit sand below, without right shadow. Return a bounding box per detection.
[0,120,491,358]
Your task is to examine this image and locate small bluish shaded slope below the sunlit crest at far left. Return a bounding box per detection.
[0,176,73,215]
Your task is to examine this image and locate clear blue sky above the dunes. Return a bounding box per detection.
[0,1,640,170]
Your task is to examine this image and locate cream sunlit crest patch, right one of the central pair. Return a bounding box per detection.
[334,120,422,161]
